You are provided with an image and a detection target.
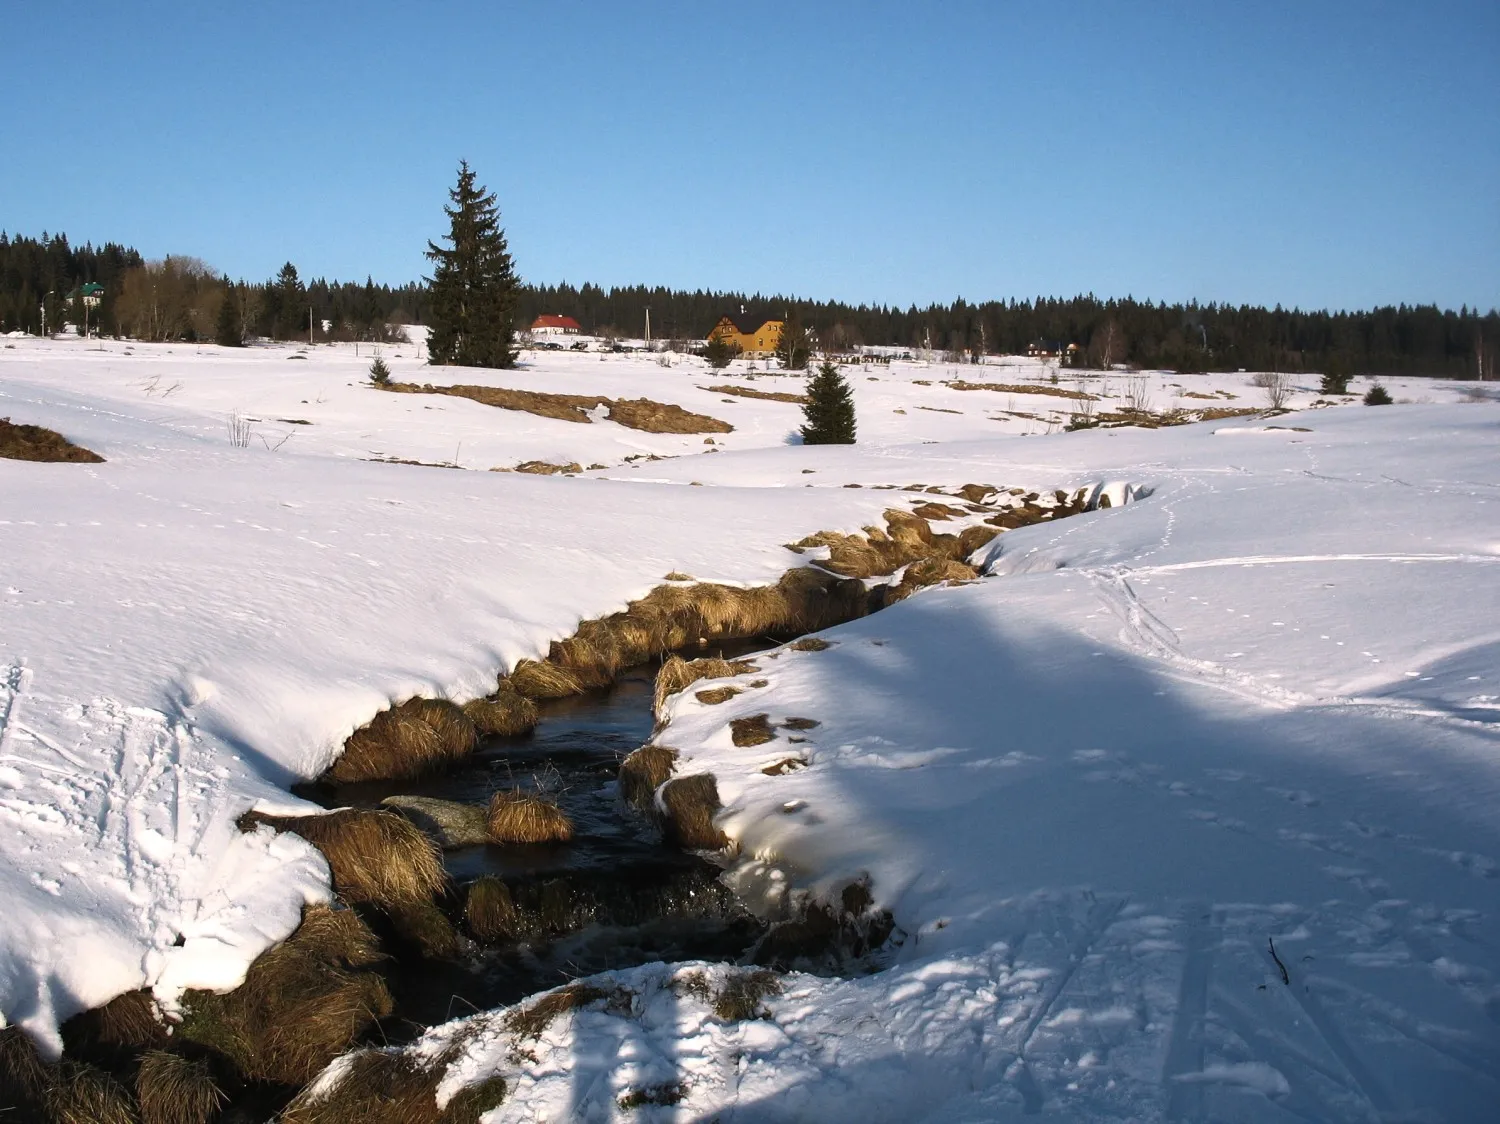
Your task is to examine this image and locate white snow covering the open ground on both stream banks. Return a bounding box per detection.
[0,341,1500,1121]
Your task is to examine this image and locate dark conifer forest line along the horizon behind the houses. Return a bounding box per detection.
[0,234,1500,378]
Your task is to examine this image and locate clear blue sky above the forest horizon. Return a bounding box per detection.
[0,0,1500,309]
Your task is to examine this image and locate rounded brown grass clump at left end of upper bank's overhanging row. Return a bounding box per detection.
[326,698,479,783]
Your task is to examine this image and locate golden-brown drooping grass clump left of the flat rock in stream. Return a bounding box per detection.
[240,807,447,906]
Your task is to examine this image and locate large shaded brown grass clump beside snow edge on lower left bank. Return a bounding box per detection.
[177,906,392,1085]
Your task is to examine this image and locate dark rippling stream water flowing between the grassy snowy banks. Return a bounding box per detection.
[308,639,767,1041]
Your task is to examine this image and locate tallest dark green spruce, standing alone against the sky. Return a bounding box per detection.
[428,161,519,368]
